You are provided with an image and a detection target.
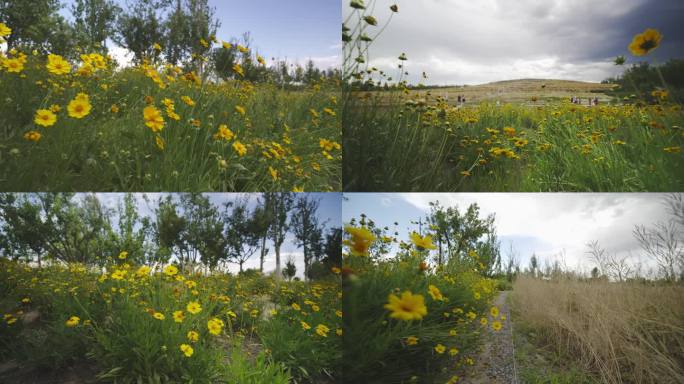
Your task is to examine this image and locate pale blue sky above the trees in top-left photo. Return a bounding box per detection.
[61,0,341,68]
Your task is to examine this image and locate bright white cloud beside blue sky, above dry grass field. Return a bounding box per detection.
[396,193,668,269]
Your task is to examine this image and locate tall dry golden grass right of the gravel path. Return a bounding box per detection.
[513,277,684,384]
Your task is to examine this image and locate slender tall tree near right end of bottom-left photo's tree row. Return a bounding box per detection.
[290,195,321,277]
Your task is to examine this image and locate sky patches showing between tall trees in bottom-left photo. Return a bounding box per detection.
[76,192,342,277]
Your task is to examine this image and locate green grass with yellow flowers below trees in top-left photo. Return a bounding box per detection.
[0,52,342,191]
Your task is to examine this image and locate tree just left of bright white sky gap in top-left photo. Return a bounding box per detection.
[71,0,121,53]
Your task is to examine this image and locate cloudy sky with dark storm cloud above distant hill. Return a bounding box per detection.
[343,0,684,85]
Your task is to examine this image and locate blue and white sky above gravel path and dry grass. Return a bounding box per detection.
[342,193,680,273]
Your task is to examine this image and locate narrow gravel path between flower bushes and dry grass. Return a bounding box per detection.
[459,291,517,384]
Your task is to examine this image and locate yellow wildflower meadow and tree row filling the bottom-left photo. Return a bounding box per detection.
[0,195,343,384]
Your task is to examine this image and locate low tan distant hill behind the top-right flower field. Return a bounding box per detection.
[412,79,615,105]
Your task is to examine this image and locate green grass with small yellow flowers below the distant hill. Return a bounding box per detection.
[343,97,684,191]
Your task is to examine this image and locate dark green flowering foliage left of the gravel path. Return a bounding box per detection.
[342,254,494,383]
